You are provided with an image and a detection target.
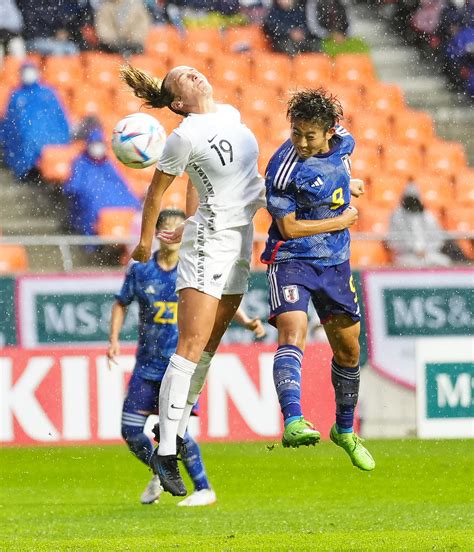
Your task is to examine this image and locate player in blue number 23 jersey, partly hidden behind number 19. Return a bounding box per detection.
[107,209,265,506]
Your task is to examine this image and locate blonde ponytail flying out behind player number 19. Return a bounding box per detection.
[120,65,175,111]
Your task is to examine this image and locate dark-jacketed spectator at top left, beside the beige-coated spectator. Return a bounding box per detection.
[17,0,91,56]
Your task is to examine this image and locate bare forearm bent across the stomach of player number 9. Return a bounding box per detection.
[276,206,358,240]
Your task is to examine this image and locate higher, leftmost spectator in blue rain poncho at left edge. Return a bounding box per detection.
[0,62,69,179]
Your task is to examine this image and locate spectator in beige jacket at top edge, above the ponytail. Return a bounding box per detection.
[95,0,151,55]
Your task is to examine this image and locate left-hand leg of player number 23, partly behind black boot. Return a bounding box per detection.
[122,371,162,504]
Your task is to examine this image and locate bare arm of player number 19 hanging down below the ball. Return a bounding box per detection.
[132,169,175,263]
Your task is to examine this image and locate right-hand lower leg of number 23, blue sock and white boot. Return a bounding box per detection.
[178,432,216,506]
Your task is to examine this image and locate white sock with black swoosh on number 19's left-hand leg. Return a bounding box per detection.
[158,354,196,456]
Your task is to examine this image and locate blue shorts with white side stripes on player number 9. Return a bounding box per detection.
[267,260,360,326]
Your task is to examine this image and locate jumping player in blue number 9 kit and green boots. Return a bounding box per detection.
[262,89,375,471]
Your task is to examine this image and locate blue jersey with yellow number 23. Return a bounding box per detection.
[115,254,178,381]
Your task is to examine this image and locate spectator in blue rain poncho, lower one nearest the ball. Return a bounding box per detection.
[63,129,140,235]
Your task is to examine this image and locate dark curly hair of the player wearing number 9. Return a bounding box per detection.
[286,88,344,132]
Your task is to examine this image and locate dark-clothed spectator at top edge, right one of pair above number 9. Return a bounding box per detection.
[305,0,349,43]
